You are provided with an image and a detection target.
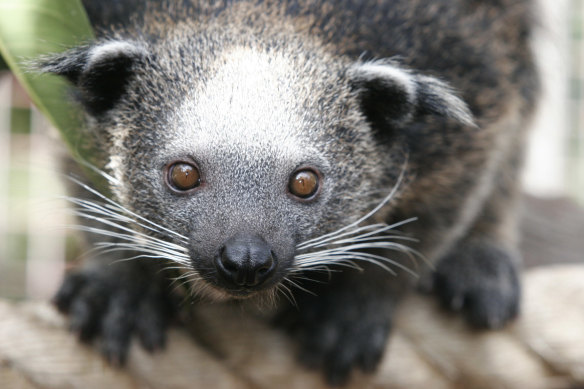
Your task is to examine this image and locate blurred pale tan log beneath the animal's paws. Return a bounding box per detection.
[0,265,584,389]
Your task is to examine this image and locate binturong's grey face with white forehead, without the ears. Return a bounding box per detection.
[112,41,385,297]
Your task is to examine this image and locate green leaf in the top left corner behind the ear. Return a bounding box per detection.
[0,0,105,190]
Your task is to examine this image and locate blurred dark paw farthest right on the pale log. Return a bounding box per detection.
[434,241,521,328]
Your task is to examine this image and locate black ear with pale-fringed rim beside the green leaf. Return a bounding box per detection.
[40,41,146,116]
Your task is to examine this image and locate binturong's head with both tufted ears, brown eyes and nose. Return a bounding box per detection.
[42,20,472,297]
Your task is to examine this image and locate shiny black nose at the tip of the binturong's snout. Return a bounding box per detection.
[215,235,276,287]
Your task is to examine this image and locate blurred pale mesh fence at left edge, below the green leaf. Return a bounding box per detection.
[0,71,78,299]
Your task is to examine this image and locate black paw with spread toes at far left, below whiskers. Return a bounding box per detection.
[54,265,174,365]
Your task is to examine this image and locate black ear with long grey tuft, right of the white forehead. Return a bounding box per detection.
[348,62,475,126]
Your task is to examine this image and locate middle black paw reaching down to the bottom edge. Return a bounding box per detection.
[282,290,391,386]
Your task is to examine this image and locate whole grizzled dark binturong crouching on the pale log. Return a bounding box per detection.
[40,0,538,385]
